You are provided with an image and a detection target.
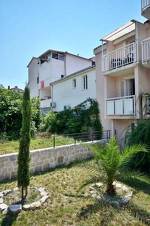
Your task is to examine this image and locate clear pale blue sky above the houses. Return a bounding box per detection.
[0,0,144,88]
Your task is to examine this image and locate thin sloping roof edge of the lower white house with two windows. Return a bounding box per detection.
[50,66,96,85]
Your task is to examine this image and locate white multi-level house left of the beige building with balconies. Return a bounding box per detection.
[28,50,96,112]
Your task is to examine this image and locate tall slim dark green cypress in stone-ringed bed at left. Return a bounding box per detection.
[18,87,31,202]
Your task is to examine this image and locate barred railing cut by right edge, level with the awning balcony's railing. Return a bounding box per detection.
[142,38,150,64]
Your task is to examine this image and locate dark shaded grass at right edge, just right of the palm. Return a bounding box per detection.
[119,177,150,195]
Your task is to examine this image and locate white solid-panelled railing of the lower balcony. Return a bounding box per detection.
[106,96,135,116]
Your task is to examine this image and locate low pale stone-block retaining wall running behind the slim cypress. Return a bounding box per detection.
[0,141,103,181]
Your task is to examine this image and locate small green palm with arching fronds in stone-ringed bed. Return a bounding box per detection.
[80,138,144,195]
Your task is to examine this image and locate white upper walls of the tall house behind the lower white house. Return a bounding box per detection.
[28,53,92,97]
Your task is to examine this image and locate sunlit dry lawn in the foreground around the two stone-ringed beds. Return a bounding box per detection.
[0,161,150,226]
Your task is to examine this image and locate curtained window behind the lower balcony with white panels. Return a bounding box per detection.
[121,79,135,96]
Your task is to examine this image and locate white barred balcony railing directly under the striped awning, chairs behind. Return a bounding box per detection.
[102,42,137,72]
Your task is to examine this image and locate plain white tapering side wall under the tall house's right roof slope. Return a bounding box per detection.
[66,54,92,75]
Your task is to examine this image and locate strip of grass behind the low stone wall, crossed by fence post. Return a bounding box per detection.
[0,136,74,155]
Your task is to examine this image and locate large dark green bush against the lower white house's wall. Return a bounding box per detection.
[41,99,102,137]
